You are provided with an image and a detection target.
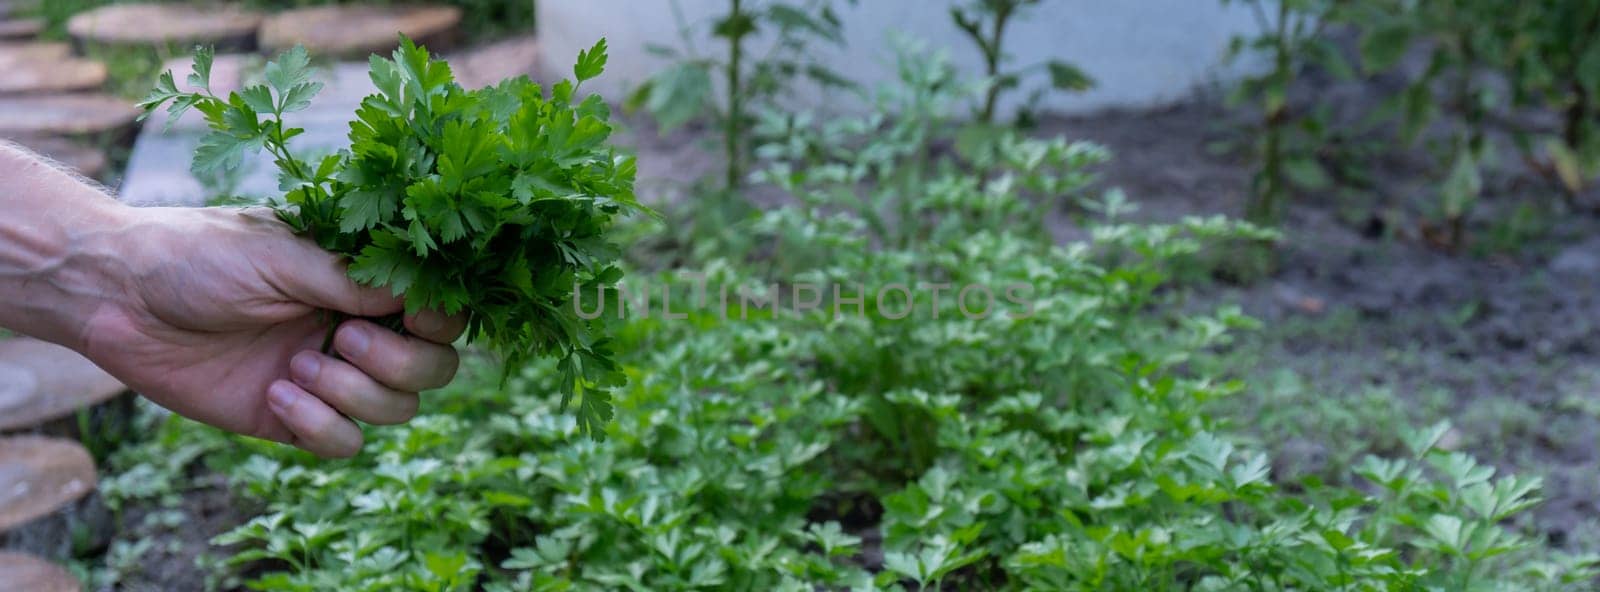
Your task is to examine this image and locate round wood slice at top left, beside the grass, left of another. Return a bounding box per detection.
[67,3,261,51]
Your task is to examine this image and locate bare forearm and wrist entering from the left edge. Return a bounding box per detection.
[0,142,133,347]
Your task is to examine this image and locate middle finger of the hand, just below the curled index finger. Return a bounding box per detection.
[333,320,461,392]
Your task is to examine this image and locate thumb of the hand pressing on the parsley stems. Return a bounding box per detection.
[267,237,405,317]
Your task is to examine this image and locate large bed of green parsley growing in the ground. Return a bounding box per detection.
[96,42,1595,592]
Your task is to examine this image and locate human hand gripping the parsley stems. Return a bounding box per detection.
[80,208,466,458]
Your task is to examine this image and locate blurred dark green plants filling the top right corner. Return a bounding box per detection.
[1224,0,1600,250]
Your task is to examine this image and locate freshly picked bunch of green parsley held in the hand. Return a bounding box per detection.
[141,38,643,437]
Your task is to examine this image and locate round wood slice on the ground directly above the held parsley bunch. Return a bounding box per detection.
[259,5,461,58]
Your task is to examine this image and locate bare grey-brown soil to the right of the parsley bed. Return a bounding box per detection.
[1042,90,1600,546]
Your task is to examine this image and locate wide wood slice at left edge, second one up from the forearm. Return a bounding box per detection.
[0,94,139,138]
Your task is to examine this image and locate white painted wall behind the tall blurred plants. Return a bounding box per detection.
[536,0,1258,114]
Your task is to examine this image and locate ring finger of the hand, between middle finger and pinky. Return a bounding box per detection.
[290,350,418,426]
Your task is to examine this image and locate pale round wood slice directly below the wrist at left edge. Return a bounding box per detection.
[0,338,128,428]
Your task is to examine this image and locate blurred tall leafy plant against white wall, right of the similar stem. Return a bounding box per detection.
[950,0,1094,123]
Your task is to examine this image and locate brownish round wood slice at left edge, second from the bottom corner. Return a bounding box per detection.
[0,435,98,531]
